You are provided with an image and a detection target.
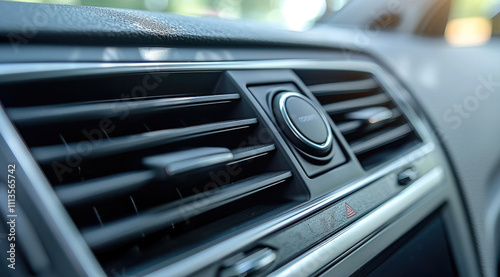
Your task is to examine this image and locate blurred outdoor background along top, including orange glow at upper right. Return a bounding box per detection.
[5,0,500,42]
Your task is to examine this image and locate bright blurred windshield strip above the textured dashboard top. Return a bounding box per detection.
[5,0,350,31]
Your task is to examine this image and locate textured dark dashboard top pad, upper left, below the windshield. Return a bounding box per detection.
[0,2,332,46]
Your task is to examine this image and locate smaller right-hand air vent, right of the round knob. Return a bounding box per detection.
[296,70,421,169]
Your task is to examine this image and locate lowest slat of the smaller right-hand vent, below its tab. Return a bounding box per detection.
[351,124,412,155]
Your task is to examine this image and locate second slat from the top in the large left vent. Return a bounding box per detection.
[31,118,257,164]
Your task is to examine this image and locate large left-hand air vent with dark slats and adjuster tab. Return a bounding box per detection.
[0,72,308,275]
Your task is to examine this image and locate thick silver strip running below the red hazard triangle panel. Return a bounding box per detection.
[269,167,444,277]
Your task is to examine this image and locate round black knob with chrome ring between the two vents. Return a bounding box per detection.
[273,92,333,157]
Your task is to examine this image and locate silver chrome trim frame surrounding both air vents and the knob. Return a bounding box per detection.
[0,59,436,276]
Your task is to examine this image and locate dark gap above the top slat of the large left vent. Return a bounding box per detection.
[2,71,223,107]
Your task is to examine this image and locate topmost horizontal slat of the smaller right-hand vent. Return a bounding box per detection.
[308,79,378,96]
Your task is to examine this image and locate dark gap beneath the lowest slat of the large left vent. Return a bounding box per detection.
[97,181,295,275]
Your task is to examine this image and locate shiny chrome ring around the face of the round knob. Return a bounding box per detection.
[278,92,333,151]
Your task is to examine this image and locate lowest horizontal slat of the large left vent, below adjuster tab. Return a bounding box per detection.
[82,171,292,249]
